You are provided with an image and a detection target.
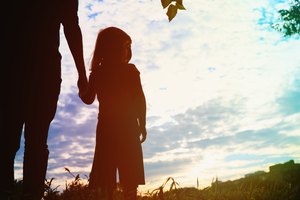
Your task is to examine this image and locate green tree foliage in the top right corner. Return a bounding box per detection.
[272,0,300,37]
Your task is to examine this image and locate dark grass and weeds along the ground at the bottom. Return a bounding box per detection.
[10,160,300,200]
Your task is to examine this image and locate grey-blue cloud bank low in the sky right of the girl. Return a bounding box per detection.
[144,92,300,188]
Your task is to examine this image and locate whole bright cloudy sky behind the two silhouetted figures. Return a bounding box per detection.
[15,0,300,192]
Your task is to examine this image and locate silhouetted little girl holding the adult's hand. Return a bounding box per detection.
[81,27,147,200]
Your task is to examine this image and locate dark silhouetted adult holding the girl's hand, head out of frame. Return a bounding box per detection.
[0,0,87,200]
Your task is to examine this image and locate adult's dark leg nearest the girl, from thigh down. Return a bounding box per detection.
[23,80,60,200]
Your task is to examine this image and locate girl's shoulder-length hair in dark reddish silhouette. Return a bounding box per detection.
[91,27,131,71]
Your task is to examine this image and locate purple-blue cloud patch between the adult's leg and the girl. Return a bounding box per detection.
[48,89,98,171]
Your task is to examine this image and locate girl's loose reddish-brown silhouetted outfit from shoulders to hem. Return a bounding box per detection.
[90,64,146,187]
